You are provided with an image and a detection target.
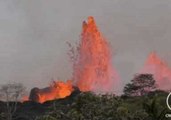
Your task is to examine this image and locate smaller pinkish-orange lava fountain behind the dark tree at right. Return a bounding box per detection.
[140,52,171,90]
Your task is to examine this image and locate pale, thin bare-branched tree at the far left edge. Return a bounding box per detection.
[0,83,25,120]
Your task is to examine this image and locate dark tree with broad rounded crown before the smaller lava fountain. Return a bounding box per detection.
[124,74,156,96]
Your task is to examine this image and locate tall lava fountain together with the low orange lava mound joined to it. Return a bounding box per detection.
[29,17,120,103]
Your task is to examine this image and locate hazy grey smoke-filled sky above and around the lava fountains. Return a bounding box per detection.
[0,0,171,88]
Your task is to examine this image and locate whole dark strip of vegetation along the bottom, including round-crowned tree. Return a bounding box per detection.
[0,74,171,120]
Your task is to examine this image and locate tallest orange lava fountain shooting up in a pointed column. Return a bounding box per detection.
[73,17,120,93]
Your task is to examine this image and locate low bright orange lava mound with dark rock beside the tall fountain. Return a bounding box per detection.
[29,81,73,103]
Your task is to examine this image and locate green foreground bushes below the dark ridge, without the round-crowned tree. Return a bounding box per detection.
[36,91,169,120]
